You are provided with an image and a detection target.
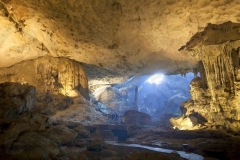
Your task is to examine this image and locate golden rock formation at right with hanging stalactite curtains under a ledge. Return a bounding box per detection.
[172,22,240,130]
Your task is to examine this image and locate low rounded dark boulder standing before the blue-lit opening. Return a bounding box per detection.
[123,110,151,125]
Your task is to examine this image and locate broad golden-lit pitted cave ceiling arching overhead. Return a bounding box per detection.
[0,0,240,80]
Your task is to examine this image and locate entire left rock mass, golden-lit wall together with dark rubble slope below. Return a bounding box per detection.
[0,56,109,160]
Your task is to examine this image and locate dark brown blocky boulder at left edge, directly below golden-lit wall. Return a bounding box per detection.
[0,82,36,119]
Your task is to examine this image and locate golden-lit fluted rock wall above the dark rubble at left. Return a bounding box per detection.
[0,56,89,99]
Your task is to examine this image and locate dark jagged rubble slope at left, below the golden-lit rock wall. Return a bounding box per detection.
[0,82,106,160]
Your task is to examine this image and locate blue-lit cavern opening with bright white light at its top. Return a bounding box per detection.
[93,73,194,123]
